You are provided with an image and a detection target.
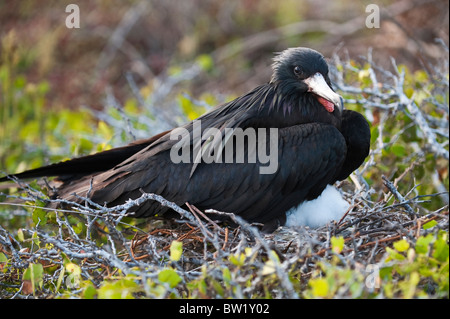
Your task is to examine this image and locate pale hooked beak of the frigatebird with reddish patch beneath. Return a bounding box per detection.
[304,72,343,113]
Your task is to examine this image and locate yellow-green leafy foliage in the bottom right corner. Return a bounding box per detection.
[303,231,449,299]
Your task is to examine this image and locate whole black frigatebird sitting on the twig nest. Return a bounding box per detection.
[0,48,370,230]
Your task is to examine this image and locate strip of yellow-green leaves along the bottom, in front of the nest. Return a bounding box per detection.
[0,210,449,299]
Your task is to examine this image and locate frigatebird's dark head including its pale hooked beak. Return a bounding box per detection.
[271,47,343,113]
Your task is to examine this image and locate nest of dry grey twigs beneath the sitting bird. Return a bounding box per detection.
[0,172,449,298]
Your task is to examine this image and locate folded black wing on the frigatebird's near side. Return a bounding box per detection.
[77,123,346,222]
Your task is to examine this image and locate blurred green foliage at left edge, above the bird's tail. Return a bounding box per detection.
[0,32,125,180]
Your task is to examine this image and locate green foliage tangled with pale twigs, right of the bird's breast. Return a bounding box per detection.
[337,61,449,210]
